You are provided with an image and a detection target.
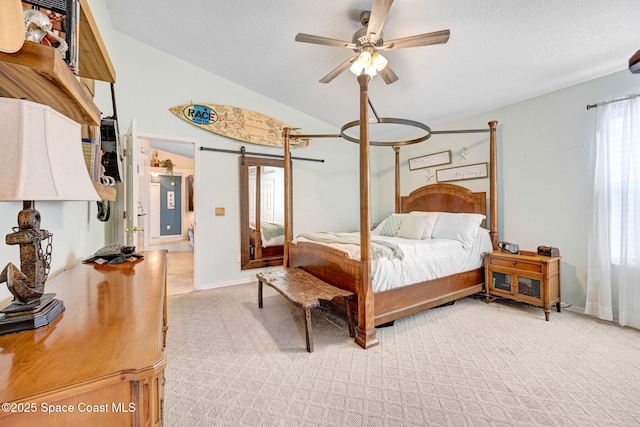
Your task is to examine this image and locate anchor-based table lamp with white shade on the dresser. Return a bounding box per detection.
[0,98,100,334]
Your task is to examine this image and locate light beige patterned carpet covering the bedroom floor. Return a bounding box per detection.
[164,284,640,427]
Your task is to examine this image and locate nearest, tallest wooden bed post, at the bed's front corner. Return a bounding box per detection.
[356,73,379,348]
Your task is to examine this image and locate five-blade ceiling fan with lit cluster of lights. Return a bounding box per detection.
[296,0,449,84]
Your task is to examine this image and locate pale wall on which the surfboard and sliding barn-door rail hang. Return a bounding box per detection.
[89,0,370,289]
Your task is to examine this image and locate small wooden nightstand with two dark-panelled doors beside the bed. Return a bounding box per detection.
[484,251,561,321]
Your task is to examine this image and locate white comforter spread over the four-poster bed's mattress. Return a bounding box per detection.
[295,227,493,292]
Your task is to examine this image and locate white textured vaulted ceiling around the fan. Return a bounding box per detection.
[106,0,640,132]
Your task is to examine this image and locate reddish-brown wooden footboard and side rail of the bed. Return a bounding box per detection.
[290,242,484,326]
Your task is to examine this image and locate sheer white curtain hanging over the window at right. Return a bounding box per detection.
[585,96,640,329]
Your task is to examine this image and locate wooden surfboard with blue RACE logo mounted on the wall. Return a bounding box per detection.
[169,104,309,148]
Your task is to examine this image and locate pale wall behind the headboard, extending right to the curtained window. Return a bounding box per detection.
[378,70,640,308]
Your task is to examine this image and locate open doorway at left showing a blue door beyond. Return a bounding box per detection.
[127,126,199,295]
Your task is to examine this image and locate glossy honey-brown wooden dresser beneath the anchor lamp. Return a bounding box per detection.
[0,251,167,427]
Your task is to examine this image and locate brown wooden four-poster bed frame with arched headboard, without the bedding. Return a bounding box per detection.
[284,75,498,348]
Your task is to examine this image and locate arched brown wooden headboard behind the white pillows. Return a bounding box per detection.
[399,184,487,226]
